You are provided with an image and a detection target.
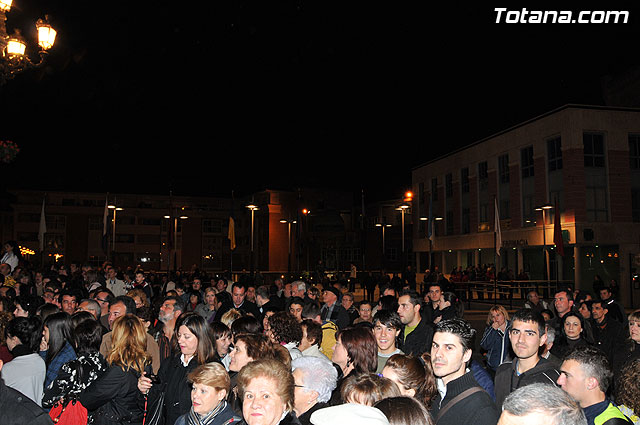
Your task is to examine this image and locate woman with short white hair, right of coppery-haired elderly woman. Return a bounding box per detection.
[291,356,338,425]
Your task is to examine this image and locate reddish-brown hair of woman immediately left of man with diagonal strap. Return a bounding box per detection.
[385,353,438,407]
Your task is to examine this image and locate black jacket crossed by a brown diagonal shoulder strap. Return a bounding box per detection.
[431,372,500,425]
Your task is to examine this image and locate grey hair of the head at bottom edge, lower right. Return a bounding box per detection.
[502,383,587,425]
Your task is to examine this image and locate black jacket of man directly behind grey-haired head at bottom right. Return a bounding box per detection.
[494,358,560,406]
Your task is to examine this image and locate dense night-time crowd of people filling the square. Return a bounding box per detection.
[0,238,640,425]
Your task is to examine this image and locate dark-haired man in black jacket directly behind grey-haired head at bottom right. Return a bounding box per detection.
[495,308,560,406]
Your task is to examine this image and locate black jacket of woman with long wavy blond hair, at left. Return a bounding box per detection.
[79,366,144,424]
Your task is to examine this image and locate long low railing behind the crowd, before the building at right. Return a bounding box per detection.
[451,280,573,309]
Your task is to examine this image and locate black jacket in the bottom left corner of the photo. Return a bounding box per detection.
[0,378,53,425]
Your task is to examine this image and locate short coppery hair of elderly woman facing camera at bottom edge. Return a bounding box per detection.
[237,359,294,412]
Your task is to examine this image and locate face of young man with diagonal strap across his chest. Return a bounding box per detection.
[431,332,472,384]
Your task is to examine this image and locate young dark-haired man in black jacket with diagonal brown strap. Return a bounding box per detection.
[431,319,500,425]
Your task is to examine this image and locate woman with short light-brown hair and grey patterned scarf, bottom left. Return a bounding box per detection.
[175,363,240,425]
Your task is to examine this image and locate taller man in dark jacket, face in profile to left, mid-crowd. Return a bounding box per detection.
[398,290,433,357]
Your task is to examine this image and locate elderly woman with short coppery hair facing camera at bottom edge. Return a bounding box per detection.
[238,359,299,425]
